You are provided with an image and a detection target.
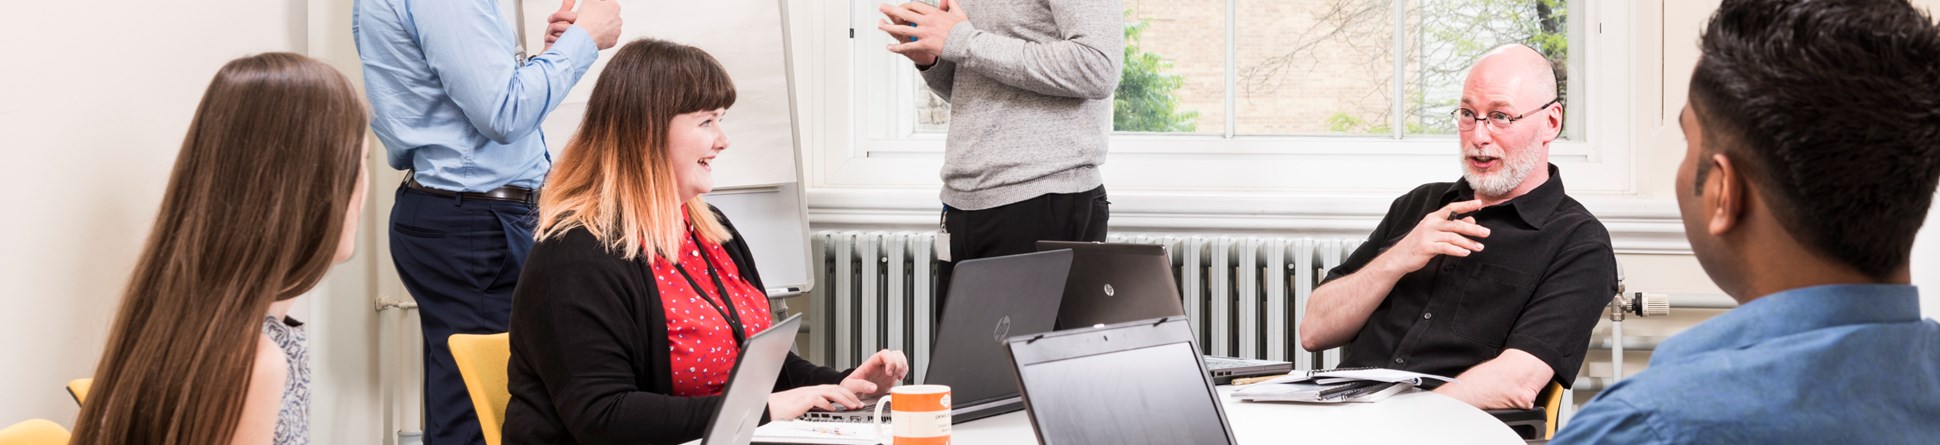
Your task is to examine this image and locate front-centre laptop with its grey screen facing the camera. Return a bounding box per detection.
[1007,317,1236,445]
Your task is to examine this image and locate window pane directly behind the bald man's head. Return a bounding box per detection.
[1405,0,1583,136]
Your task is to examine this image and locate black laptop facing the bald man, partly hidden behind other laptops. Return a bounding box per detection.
[1038,241,1294,385]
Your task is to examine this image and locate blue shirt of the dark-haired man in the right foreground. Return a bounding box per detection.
[1552,286,1940,443]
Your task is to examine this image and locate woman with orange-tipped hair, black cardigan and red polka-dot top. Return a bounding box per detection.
[504,39,908,443]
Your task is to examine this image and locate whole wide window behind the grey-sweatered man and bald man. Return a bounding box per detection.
[910,0,1579,138]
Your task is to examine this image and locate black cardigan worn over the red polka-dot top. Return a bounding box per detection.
[504,210,848,443]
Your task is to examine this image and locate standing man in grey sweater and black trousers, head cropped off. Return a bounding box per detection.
[877,0,1125,312]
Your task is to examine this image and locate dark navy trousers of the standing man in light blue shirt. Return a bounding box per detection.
[390,187,537,445]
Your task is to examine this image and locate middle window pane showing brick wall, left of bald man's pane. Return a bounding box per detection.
[1234,0,1395,134]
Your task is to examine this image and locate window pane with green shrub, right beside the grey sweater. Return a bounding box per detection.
[1112,0,1226,134]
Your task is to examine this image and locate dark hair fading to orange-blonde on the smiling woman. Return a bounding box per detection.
[537,39,735,262]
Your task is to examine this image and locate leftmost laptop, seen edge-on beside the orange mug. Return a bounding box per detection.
[700,313,801,445]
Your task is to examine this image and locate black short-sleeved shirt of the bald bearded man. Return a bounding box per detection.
[1321,165,1616,387]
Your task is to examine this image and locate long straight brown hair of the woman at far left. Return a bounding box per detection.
[72,52,369,445]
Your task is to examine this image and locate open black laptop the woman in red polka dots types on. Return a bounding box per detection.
[801,251,1071,424]
